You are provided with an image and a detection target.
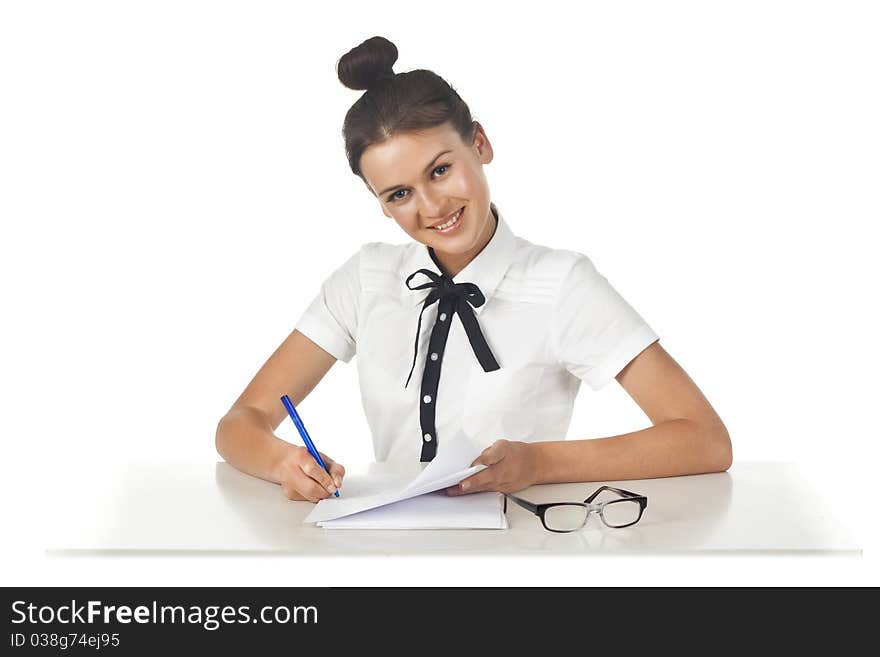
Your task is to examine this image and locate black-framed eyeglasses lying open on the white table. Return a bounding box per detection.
[504,486,648,532]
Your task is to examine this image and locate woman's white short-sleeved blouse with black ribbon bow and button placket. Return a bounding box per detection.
[296,203,659,461]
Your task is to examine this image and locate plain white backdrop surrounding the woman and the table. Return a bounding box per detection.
[0,0,880,586]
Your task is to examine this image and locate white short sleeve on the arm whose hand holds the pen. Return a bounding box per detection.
[296,251,361,363]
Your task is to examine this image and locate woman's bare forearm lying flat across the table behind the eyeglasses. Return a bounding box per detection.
[532,419,732,483]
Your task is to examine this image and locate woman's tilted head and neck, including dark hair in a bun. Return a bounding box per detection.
[338,37,495,276]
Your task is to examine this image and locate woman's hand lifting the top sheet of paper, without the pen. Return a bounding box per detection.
[446,439,537,495]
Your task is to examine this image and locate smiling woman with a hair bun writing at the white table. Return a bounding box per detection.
[216,37,732,501]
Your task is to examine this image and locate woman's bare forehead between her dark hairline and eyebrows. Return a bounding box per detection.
[361,123,464,192]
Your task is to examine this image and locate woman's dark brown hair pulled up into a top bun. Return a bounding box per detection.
[336,36,476,193]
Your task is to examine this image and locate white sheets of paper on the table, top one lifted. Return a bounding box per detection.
[303,431,507,529]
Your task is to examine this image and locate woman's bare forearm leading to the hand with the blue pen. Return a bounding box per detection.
[215,407,290,483]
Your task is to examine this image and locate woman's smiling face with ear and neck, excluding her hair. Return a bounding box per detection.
[360,122,495,276]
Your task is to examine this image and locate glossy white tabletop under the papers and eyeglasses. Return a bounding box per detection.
[48,462,861,555]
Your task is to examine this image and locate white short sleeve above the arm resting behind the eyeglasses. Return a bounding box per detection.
[551,254,659,390]
